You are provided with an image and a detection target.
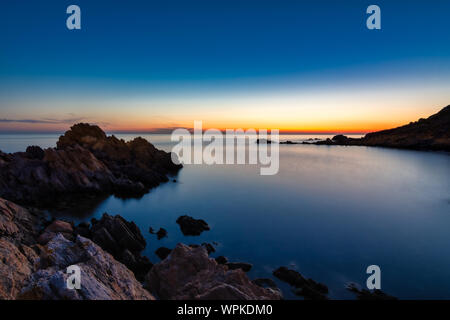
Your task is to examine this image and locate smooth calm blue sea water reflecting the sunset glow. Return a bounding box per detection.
[0,135,450,298]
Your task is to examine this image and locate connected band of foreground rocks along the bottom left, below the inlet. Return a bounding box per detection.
[0,198,282,300]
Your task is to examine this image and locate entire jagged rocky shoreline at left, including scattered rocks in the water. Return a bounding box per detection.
[0,124,398,300]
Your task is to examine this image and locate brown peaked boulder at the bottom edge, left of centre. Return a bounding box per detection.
[146,244,281,300]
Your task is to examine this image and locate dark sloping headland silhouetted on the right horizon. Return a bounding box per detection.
[314,105,450,151]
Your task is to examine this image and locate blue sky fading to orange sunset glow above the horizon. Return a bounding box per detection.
[0,0,450,133]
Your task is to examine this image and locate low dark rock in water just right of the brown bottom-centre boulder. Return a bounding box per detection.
[273,267,328,300]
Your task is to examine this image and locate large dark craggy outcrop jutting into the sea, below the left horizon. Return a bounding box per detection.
[0,124,181,207]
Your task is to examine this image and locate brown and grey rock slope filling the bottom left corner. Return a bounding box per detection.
[0,198,154,300]
